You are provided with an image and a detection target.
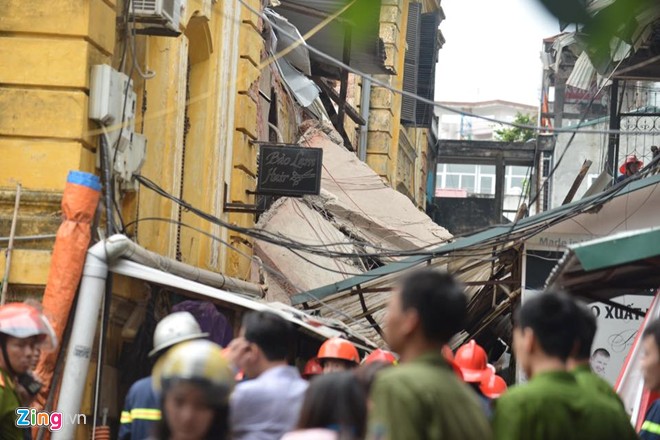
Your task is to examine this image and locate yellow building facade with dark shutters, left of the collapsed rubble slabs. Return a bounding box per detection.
[0,0,444,438]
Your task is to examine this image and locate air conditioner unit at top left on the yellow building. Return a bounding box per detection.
[128,0,186,35]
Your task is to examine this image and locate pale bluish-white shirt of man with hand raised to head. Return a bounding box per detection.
[230,366,307,440]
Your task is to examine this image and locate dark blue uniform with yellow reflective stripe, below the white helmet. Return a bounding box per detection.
[119,376,161,440]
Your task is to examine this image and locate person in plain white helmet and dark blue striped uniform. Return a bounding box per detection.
[119,312,208,440]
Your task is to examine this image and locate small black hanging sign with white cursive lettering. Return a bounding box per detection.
[257,145,323,196]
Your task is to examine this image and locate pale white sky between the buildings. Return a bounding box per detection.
[435,0,559,105]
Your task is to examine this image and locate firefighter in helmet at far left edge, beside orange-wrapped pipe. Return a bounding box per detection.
[0,303,57,440]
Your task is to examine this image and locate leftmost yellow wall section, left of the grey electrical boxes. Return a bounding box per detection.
[0,0,115,291]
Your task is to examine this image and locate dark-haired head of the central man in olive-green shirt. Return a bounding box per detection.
[385,270,467,357]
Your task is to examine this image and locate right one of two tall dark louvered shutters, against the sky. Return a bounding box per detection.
[415,12,440,126]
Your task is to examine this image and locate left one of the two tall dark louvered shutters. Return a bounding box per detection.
[401,3,422,123]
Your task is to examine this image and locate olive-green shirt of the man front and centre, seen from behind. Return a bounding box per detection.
[367,353,492,440]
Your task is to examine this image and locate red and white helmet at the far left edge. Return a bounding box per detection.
[0,303,57,351]
